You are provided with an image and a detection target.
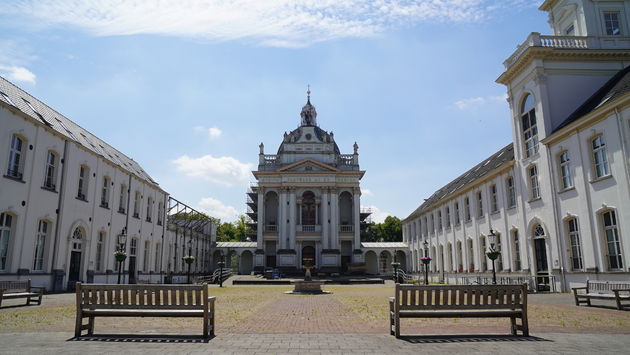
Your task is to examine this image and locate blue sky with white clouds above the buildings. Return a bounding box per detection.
[0,0,549,220]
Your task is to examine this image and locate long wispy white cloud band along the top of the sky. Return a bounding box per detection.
[0,0,532,47]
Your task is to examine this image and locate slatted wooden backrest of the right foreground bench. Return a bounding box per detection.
[396,284,527,310]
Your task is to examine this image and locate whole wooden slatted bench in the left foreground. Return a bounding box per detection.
[74,283,216,338]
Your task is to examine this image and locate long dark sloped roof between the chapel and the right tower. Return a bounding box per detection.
[405,143,514,219]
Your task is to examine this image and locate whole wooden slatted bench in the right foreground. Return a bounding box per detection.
[389,284,529,338]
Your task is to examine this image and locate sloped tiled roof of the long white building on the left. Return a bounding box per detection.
[0,76,158,187]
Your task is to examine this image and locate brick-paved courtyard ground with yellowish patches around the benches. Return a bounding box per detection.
[0,283,630,354]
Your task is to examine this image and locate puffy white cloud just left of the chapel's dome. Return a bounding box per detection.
[173,154,252,186]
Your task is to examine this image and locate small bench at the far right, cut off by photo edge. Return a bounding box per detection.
[573,280,630,310]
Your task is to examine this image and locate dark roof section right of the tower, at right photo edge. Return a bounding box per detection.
[552,66,630,133]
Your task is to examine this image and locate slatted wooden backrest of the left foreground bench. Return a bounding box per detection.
[77,284,207,310]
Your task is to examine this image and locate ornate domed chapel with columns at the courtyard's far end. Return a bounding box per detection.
[248,90,370,273]
